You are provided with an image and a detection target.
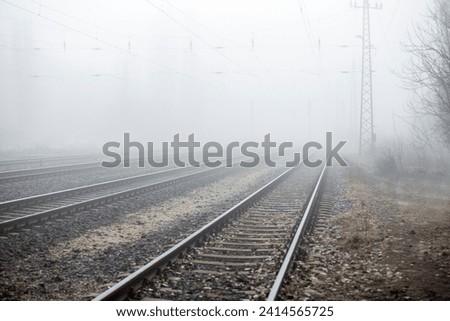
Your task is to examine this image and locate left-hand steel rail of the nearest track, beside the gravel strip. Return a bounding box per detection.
[93,167,298,301]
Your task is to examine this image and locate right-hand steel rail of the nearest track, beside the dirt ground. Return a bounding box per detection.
[266,163,327,301]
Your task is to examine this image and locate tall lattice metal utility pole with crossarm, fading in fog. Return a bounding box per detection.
[350,0,382,154]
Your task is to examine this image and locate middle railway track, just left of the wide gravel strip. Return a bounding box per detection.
[0,167,222,234]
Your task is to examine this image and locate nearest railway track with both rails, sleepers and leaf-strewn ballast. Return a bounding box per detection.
[94,162,326,300]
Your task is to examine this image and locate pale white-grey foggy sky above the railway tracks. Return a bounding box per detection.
[0,0,430,153]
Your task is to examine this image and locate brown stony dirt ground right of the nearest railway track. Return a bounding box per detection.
[281,165,450,300]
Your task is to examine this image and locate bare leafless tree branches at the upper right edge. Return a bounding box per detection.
[401,0,450,149]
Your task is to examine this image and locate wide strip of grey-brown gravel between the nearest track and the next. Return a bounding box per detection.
[0,168,279,300]
